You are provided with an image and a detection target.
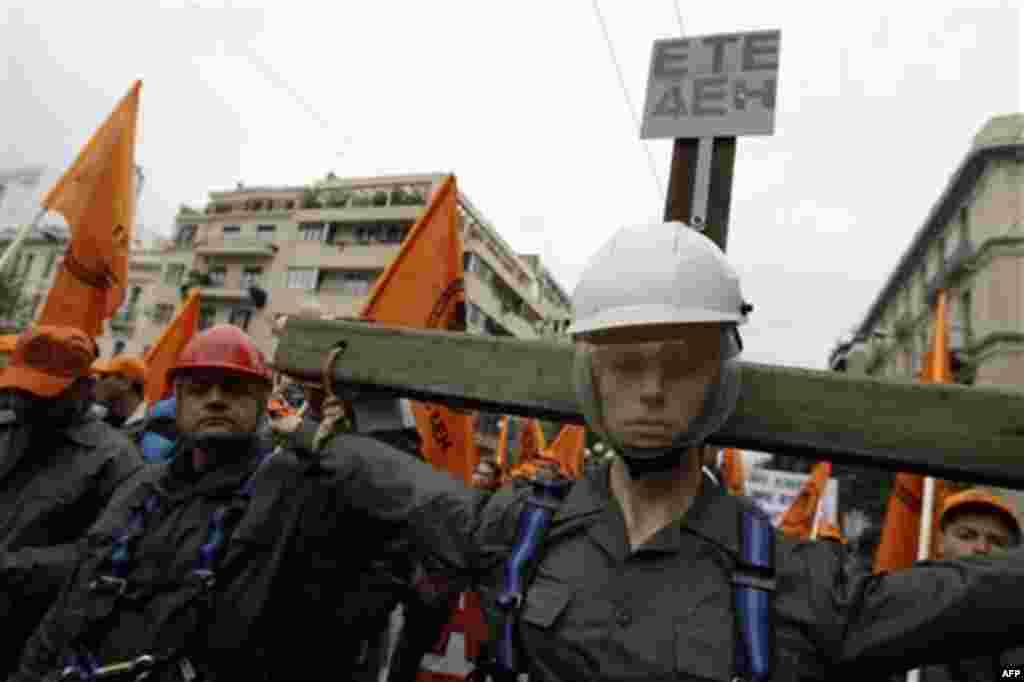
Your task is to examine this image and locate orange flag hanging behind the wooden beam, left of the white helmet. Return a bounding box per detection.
[361,175,479,483]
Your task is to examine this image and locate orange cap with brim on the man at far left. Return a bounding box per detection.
[0,325,96,397]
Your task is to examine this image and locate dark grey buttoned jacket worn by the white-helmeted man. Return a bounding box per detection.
[313,436,1024,682]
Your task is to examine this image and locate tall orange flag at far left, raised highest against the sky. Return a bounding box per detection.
[38,81,142,337]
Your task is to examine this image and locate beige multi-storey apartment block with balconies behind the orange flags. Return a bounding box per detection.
[0,174,571,454]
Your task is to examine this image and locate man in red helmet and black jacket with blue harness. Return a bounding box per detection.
[12,325,411,681]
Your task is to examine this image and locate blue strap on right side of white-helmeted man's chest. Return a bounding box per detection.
[732,510,775,682]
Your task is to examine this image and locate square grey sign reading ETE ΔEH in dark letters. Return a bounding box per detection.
[640,31,781,139]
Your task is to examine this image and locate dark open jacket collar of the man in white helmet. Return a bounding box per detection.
[553,456,741,555]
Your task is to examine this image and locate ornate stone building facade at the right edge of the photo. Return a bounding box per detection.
[815,114,1024,552]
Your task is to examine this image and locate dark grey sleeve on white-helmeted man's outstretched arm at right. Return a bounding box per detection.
[778,543,1024,674]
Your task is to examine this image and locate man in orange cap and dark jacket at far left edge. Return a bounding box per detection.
[0,327,141,676]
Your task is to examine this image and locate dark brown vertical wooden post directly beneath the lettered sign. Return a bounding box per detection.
[665,137,736,251]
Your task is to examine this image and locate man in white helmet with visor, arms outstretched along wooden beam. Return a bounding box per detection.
[311,223,1024,682]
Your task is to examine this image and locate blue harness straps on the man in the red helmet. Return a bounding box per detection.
[61,451,274,682]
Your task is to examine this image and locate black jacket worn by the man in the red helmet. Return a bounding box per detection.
[11,430,409,682]
